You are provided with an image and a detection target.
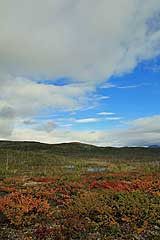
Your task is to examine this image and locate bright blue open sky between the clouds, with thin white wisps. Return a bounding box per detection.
[31,57,160,143]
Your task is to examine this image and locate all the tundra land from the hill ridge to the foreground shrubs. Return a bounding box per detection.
[0,141,160,240]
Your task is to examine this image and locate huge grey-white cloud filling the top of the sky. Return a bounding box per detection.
[0,0,160,81]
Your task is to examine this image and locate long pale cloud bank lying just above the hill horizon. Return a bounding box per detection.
[7,115,160,147]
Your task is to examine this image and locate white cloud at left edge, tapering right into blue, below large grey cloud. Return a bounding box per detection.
[0,75,96,137]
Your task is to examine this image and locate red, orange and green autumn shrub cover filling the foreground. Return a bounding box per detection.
[0,170,160,240]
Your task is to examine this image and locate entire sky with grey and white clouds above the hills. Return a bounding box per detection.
[0,0,160,147]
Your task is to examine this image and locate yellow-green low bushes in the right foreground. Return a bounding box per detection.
[63,191,160,239]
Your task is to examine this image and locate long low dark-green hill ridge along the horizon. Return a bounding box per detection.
[0,141,160,161]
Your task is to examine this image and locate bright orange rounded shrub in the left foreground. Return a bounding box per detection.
[1,192,50,226]
